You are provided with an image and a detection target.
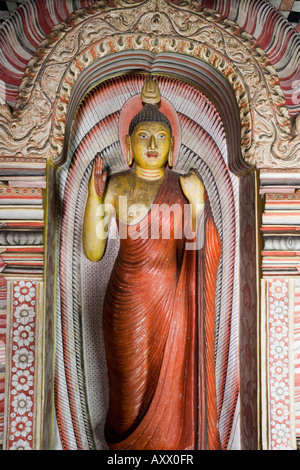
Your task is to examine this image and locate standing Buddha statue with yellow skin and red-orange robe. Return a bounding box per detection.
[83,80,221,450]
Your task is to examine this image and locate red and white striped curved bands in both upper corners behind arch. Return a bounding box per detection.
[0,0,300,115]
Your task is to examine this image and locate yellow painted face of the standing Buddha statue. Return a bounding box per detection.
[130,122,173,170]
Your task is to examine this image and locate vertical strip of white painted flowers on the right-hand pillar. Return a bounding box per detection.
[268,279,291,450]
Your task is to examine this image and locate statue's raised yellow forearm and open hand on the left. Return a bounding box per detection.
[82,166,111,261]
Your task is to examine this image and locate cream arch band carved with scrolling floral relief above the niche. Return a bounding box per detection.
[0,0,300,168]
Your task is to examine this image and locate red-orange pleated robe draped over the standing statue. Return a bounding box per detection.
[103,170,221,450]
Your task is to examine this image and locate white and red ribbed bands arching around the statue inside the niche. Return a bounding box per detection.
[57,76,238,448]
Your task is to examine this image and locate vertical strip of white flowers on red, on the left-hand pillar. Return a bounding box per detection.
[9,280,36,450]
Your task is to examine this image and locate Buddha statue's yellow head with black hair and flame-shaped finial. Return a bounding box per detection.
[126,80,174,170]
